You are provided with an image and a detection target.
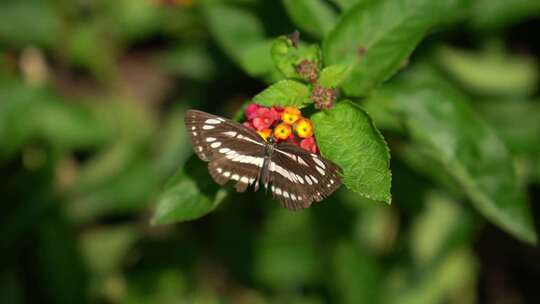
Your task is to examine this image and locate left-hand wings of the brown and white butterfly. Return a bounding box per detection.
[185,110,265,192]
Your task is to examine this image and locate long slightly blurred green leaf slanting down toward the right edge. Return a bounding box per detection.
[388,80,536,243]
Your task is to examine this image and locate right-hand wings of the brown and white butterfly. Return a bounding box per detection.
[269,143,341,210]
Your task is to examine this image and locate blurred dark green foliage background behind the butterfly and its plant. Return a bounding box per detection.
[0,0,540,304]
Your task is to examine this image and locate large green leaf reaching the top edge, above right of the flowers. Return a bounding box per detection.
[323,0,440,96]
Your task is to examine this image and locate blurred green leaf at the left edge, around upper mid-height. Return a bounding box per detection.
[0,80,108,157]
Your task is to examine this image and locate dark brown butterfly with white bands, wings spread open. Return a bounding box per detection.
[184,110,341,210]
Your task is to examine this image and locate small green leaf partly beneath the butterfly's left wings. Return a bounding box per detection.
[152,156,227,225]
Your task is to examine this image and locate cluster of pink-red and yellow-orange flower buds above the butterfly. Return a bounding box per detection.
[244,103,317,153]
